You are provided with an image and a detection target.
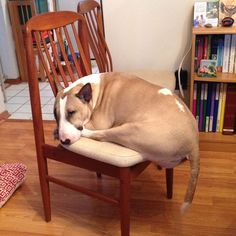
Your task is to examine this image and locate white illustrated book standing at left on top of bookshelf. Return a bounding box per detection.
[193,0,219,27]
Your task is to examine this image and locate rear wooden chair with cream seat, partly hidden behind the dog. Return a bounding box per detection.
[77,0,176,92]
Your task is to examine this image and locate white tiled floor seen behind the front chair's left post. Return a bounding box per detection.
[6,82,54,120]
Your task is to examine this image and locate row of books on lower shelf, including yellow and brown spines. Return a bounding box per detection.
[193,82,236,134]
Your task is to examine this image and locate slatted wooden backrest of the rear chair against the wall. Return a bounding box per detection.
[77,0,113,72]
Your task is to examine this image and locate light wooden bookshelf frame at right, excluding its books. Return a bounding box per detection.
[190,26,236,152]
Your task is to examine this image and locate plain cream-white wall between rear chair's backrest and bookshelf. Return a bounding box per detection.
[103,0,194,71]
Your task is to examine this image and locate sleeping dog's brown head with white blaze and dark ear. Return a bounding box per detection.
[54,83,92,145]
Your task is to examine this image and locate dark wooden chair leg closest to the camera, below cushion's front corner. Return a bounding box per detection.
[120,168,131,236]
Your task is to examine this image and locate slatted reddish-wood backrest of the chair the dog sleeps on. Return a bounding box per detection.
[26,11,91,144]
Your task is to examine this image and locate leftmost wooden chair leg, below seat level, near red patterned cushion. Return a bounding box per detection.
[38,157,51,222]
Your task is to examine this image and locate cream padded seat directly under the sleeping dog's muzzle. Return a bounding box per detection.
[62,137,146,167]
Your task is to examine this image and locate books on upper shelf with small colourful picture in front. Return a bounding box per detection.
[194,34,236,74]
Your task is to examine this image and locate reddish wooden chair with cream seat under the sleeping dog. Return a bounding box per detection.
[26,11,173,236]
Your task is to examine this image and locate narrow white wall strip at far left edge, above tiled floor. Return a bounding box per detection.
[0,0,19,79]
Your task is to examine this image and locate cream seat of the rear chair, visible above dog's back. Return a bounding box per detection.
[128,70,176,92]
